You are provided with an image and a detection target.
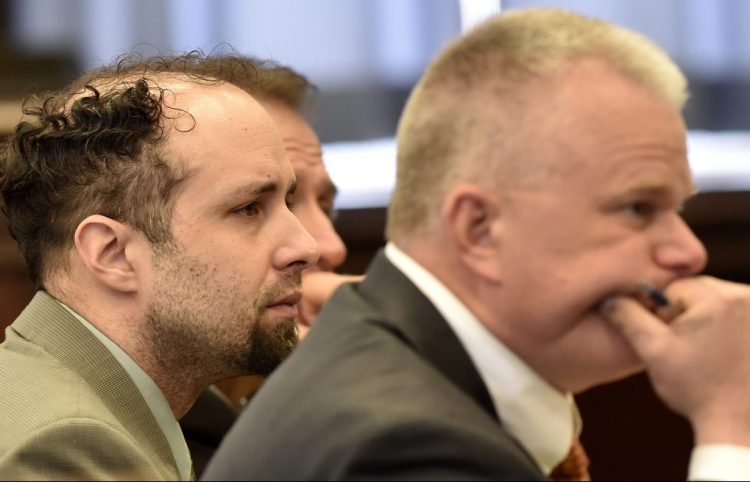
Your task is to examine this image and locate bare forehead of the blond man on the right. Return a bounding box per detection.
[529,61,693,192]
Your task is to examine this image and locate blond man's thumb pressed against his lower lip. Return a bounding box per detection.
[599,296,672,364]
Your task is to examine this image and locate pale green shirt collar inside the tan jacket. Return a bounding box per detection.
[58,301,193,480]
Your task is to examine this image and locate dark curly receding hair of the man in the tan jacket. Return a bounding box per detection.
[0,51,245,288]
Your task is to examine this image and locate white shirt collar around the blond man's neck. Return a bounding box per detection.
[385,243,581,475]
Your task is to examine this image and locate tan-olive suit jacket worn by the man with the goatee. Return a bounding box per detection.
[0,291,179,480]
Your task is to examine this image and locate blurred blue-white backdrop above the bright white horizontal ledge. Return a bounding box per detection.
[0,0,750,137]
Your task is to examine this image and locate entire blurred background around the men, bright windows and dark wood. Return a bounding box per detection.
[0,0,750,480]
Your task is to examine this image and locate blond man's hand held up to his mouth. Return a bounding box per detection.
[602,277,750,446]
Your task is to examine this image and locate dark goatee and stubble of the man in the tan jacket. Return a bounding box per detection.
[144,247,301,383]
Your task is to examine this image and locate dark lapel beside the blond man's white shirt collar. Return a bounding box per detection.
[359,251,499,420]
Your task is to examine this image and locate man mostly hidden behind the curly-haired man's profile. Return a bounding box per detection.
[173,54,361,477]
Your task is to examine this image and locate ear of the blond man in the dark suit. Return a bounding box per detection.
[442,184,501,282]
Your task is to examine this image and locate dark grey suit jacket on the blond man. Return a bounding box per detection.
[204,253,544,480]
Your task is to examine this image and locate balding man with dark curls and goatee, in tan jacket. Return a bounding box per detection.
[0,54,318,480]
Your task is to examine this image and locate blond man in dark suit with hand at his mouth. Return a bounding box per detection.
[206,9,750,480]
